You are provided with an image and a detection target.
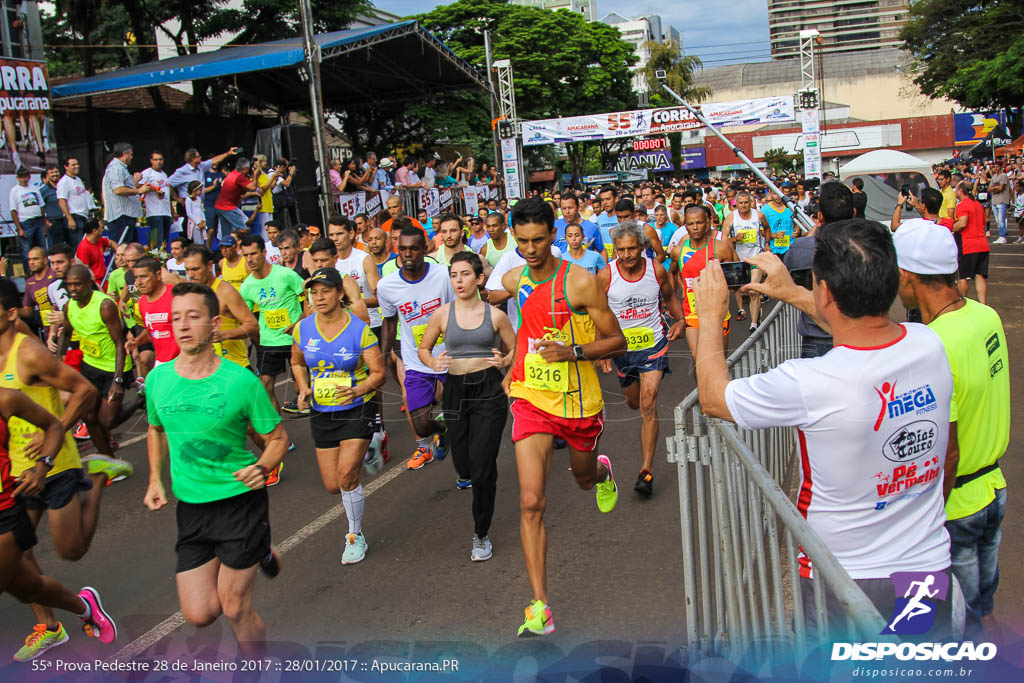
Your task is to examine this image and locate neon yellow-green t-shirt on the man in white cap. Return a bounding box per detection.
[928,299,1010,519]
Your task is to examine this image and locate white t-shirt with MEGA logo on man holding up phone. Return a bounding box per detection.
[725,323,952,579]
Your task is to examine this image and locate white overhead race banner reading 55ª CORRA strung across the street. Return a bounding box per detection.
[522,96,796,146]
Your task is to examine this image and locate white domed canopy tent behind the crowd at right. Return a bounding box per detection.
[839,150,935,225]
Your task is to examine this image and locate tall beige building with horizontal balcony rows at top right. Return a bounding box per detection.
[768,0,910,59]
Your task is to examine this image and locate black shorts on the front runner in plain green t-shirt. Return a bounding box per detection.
[174,488,270,572]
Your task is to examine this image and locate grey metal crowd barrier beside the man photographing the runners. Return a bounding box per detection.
[667,303,887,655]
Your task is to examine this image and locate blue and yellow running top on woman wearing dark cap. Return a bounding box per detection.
[293,313,377,413]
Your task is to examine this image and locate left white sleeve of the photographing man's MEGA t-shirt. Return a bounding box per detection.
[725,360,810,429]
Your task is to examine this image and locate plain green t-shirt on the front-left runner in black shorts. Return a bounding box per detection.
[145,359,281,503]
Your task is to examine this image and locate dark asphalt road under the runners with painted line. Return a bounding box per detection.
[0,246,1024,681]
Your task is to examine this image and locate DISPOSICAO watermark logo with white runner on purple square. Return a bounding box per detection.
[831,571,996,661]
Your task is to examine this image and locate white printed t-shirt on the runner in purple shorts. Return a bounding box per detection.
[377,261,455,375]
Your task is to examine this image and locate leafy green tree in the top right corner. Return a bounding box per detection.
[900,0,1024,135]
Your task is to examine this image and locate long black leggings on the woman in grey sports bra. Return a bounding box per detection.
[441,368,509,539]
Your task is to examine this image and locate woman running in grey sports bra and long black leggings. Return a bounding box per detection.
[418,253,515,562]
